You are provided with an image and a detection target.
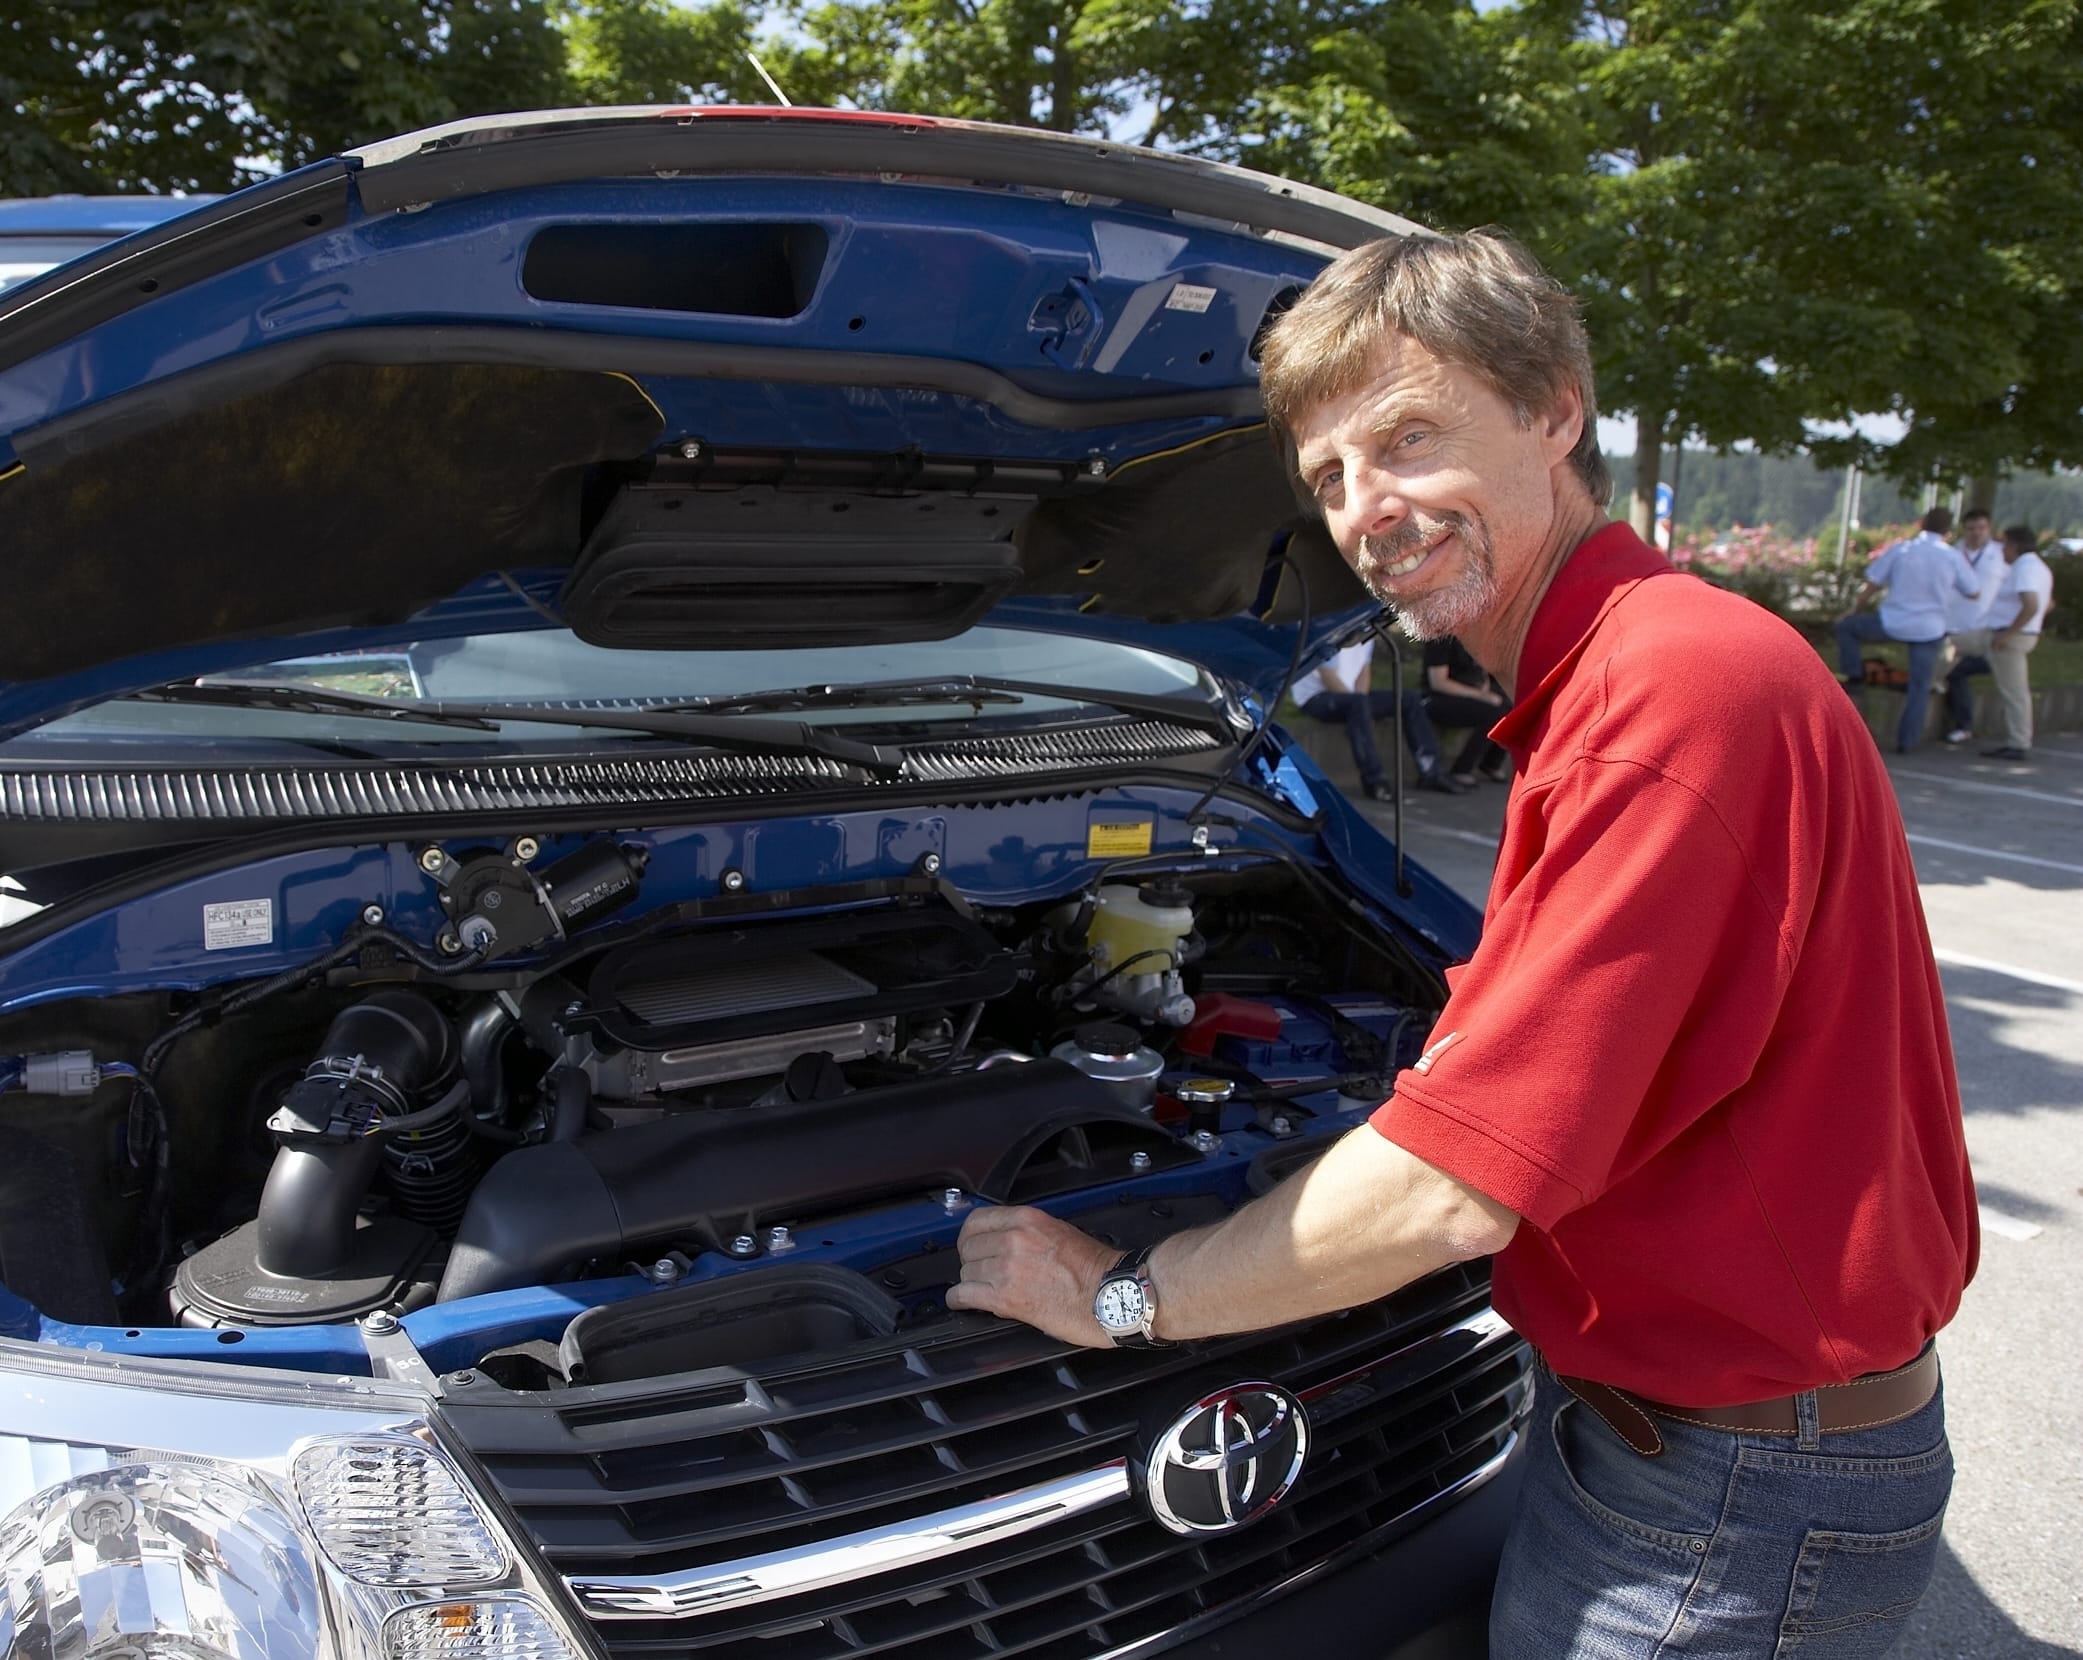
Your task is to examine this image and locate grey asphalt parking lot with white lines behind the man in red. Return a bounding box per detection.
[1369,733,2083,1660]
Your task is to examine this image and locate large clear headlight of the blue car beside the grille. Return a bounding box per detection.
[0,1343,594,1660]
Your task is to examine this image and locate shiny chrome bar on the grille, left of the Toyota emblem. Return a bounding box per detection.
[564,1458,1129,1620]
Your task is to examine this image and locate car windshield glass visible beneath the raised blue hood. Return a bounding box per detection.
[0,627,1212,762]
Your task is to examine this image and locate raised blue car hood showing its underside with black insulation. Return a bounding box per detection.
[0,108,1416,731]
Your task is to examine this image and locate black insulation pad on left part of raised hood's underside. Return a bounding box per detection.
[0,354,660,681]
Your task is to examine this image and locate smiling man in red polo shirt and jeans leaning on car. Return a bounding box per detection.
[948,235,1977,1660]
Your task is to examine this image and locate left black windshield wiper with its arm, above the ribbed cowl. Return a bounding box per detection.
[131,681,904,777]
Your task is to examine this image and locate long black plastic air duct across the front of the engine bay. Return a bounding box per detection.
[437,1060,1198,1302]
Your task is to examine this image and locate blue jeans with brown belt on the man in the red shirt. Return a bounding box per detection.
[1489,1366,1952,1660]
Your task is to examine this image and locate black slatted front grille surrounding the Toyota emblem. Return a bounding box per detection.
[448,1264,1529,1660]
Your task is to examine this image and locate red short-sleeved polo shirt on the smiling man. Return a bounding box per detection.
[1373,525,1977,1406]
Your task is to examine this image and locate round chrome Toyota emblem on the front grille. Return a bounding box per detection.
[1144,1383,1308,1533]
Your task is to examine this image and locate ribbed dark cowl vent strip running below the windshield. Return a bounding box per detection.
[0,721,1221,823]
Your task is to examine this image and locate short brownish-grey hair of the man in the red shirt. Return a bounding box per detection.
[1258,231,1612,508]
